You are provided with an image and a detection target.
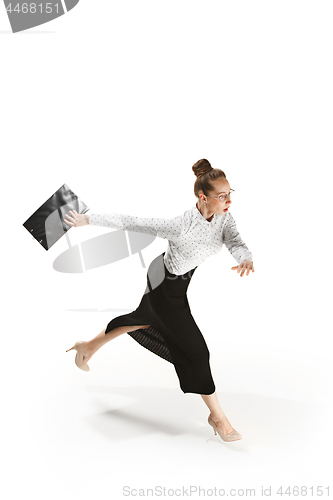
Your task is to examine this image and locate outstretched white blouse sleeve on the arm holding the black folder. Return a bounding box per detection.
[88,213,183,240]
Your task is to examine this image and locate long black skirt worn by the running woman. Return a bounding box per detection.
[105,252,215,394]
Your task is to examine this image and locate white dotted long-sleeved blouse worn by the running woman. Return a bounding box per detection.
[87,205,253,275]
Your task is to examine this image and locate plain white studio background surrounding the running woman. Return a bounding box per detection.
[0,0,333,500]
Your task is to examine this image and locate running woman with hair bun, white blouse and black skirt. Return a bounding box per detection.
[64,159,254,441]
